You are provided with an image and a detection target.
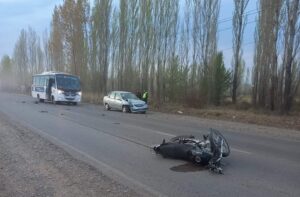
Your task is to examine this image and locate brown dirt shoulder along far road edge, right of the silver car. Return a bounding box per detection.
[152,104,300,131]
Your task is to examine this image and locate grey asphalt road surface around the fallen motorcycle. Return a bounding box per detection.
[0,93,300,196]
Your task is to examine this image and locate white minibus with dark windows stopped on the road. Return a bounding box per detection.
[31,71,82,105]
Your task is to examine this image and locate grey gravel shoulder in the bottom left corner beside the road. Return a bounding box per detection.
[0,114,140,197]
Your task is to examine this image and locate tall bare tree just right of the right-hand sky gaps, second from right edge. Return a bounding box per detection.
[252,0,282,110]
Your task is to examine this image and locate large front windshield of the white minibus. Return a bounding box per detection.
[56,75,80,91]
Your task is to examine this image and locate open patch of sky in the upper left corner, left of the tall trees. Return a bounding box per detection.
[0,0,63,57]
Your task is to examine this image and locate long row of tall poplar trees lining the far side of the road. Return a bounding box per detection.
[2,0,300,112]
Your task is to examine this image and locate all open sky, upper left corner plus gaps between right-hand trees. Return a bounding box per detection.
[0,0,257,67]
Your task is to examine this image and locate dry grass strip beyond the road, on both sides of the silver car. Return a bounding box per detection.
[83,93,300,130]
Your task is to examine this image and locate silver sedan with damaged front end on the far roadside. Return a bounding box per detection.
[103,91,148,113]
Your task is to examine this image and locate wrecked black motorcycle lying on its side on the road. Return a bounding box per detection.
[153,129,230,174]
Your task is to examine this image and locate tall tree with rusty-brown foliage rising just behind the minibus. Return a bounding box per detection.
[59,0,89,87]
